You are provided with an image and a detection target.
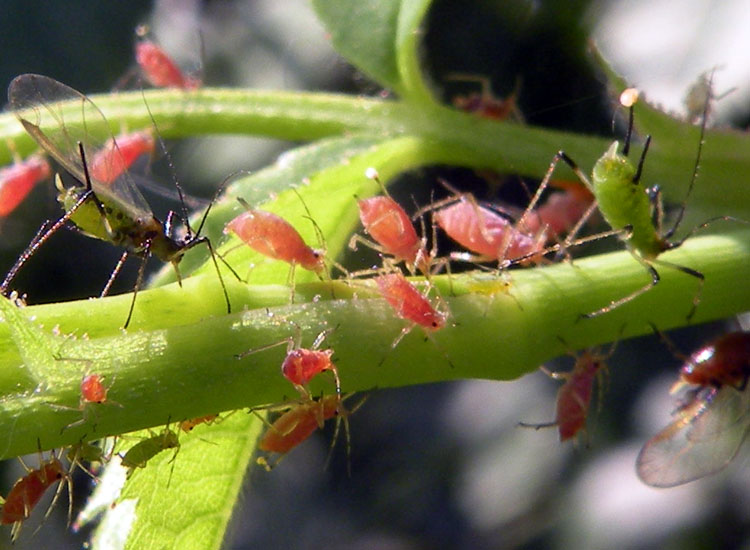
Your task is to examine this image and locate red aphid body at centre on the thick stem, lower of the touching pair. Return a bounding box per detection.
[375,273,446,331]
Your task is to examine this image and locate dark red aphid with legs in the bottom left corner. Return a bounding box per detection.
[0,455,73,540]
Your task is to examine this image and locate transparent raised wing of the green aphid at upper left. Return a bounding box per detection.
[8,74,151,217]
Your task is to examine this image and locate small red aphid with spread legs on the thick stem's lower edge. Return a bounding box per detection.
[237,325,341,401]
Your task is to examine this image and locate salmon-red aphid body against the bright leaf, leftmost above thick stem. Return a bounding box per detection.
[224,208,325,273]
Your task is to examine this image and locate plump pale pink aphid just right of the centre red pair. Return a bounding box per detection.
[433,195,547,263]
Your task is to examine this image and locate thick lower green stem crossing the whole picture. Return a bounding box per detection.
[0,230,750,457]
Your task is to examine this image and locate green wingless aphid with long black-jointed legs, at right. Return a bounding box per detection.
[524,76,742,319]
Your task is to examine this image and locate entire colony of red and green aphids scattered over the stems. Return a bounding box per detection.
[0,31,750,536]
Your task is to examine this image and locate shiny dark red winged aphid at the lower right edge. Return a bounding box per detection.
[636,332,750,487]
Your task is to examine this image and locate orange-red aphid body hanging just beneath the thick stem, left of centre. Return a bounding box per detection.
[258,395,341,454]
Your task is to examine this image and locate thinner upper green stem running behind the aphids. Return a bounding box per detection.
[0,88,750,215]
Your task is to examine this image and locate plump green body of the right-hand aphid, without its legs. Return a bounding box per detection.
[592,141,664,259]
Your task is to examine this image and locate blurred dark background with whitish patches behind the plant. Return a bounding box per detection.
[0,0,750,550]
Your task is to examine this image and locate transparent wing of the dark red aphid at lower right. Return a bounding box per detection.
[636,386,750,487]
